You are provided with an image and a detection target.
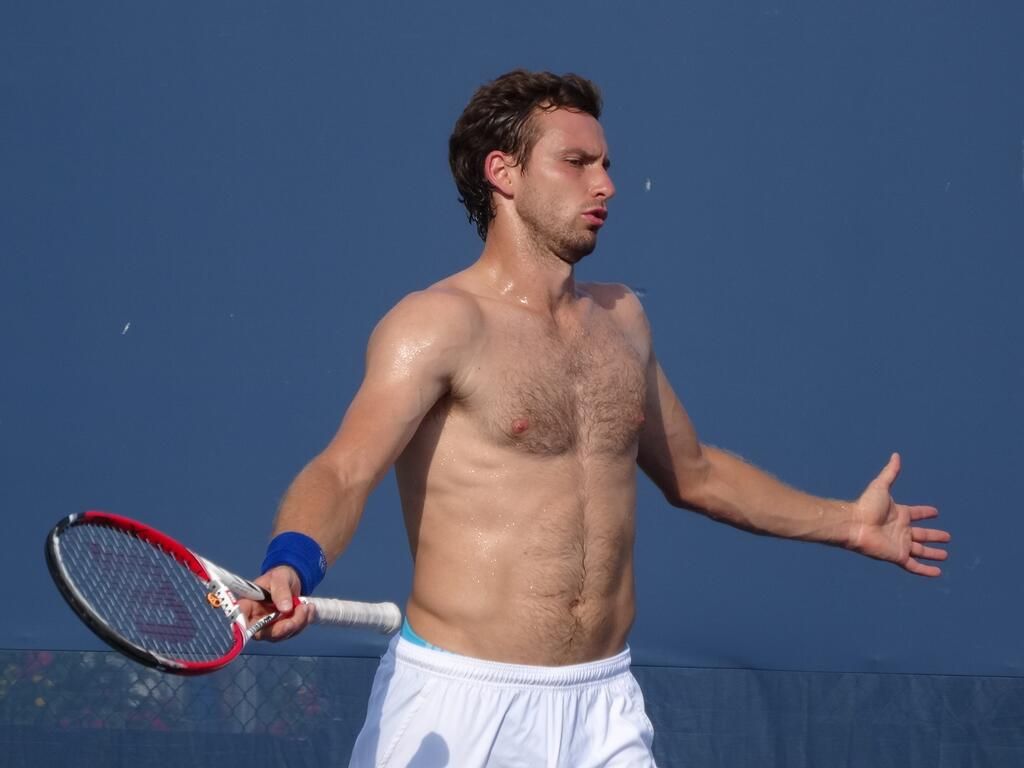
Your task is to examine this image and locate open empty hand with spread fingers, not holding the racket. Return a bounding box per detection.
[850,454,949,577]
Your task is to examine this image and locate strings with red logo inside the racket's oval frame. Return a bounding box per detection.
[59,523,236,662]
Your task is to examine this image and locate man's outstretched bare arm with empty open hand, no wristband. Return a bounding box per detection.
[637,352,949,577]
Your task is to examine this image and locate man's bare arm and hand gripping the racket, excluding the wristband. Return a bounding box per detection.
[257,291,479,640]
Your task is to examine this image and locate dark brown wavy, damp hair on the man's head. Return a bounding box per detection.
[449,70,601,240]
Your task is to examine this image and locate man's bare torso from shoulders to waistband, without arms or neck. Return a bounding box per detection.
[396,278,650,665]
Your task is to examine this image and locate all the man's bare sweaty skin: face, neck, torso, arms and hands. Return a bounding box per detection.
[247,110,949,665]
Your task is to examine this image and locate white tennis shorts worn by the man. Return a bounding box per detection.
[349,635,654,768]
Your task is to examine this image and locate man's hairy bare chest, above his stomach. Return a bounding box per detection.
[477,313,646,455]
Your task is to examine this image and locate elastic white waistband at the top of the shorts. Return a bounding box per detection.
[391,635,631,688]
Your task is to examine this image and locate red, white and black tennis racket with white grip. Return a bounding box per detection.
[46,511,401,675]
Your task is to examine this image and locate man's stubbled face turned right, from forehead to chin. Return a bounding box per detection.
[515,110,615,264]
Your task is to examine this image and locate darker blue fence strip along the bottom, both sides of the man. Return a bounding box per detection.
[0,650,1024,768]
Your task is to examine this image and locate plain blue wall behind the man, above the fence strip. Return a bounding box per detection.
[6,0,1024,676]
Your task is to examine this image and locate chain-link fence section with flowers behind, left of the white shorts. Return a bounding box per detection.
[0,650,378,767]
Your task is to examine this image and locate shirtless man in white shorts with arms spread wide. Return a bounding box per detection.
[251,71,949,768]
